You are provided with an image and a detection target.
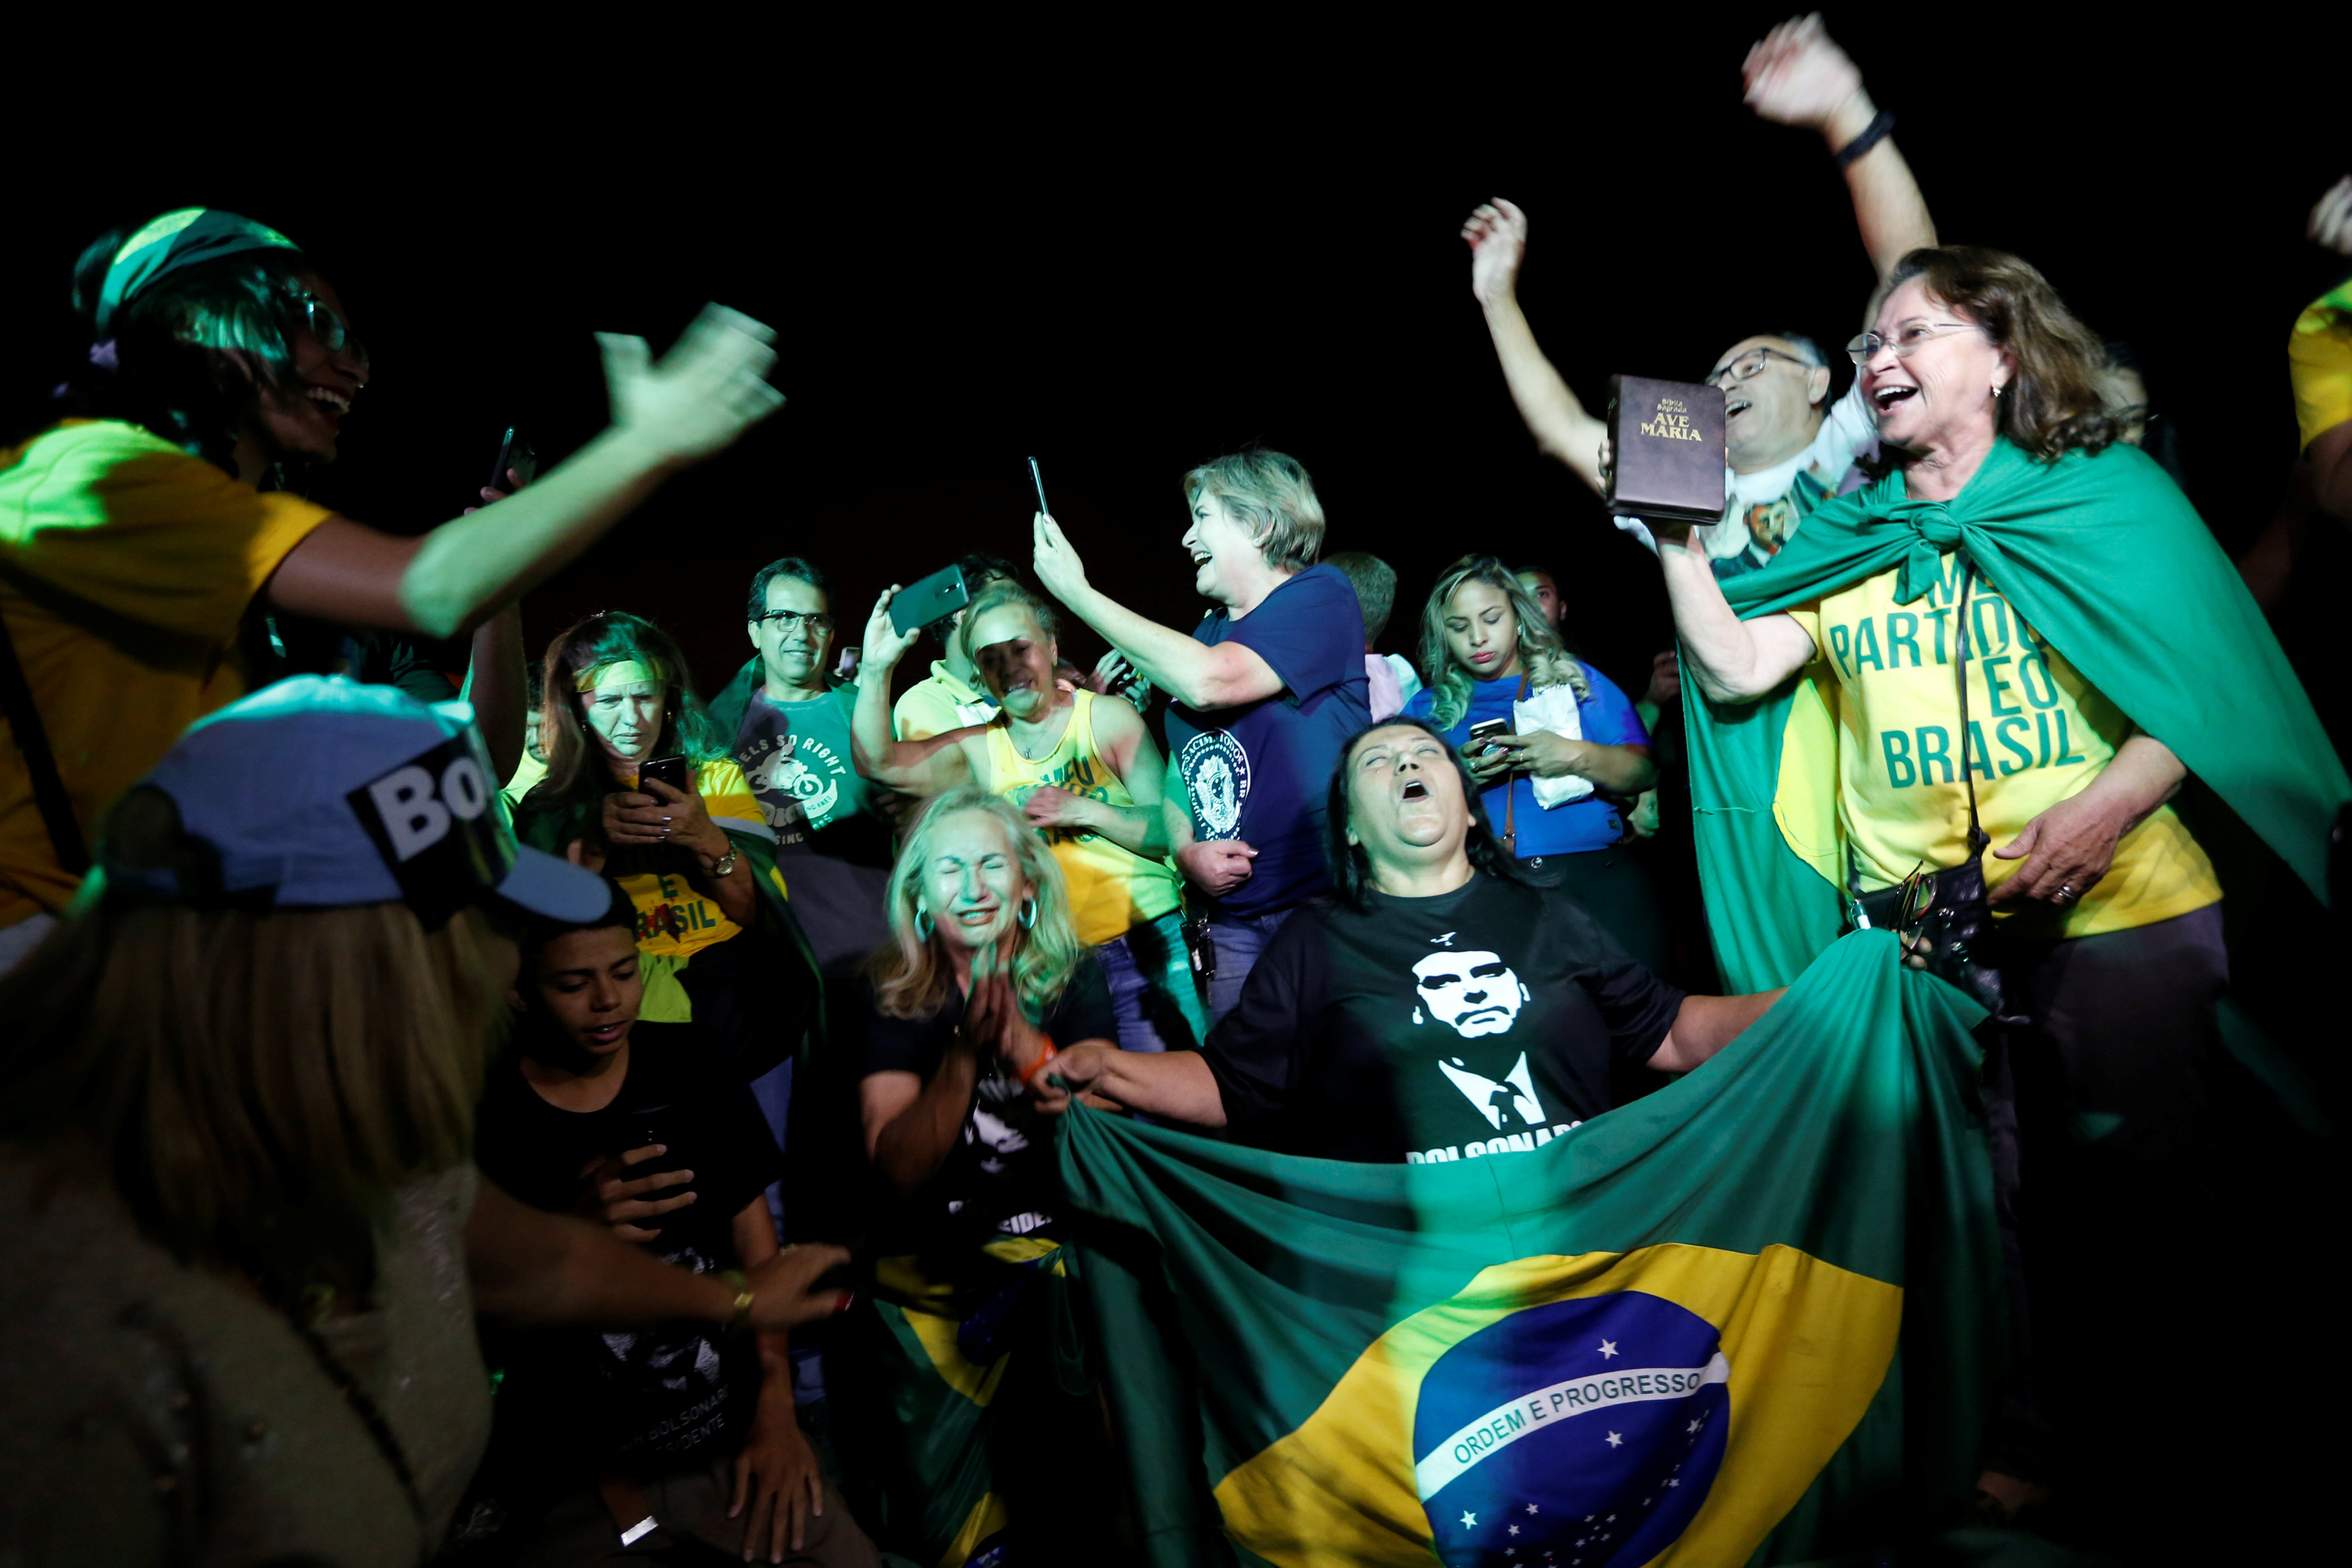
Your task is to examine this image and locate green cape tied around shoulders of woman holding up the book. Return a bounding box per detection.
[1684,439,2352,992]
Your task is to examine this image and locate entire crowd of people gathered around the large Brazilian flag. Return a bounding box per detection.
[0,19,2352,1566]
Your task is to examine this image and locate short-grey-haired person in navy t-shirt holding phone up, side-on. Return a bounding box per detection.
[1035,451,1372,1020]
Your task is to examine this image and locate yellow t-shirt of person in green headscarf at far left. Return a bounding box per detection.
[0,419,329,926]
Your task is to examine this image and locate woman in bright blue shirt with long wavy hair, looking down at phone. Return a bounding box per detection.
[1404,555,1668,969]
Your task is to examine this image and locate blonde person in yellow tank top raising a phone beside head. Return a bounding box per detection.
[851,583,1209,1051]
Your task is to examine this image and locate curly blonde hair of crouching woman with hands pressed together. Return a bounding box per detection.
[873,785,1087,1022]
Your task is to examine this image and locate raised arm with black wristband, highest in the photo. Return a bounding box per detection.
[1740,11,1936,282]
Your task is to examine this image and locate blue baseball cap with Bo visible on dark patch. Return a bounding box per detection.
[114,674,612,926]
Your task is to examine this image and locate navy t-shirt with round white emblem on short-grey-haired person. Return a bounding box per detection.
[1169,566,1372,914]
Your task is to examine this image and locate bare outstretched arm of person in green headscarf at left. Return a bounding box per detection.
[268,306,784,637]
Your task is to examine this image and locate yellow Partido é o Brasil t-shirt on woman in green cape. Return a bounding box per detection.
[1790,552,2220,936]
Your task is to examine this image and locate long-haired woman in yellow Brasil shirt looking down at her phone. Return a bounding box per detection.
[515,611,816,1079]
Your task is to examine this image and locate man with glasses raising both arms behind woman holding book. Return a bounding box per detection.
[1463,16,1936,576]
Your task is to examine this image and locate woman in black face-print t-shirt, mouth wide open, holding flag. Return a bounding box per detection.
[1038,720,1781,1164]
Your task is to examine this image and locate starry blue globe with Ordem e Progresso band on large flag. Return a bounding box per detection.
[1414,1291,1731,1568]
